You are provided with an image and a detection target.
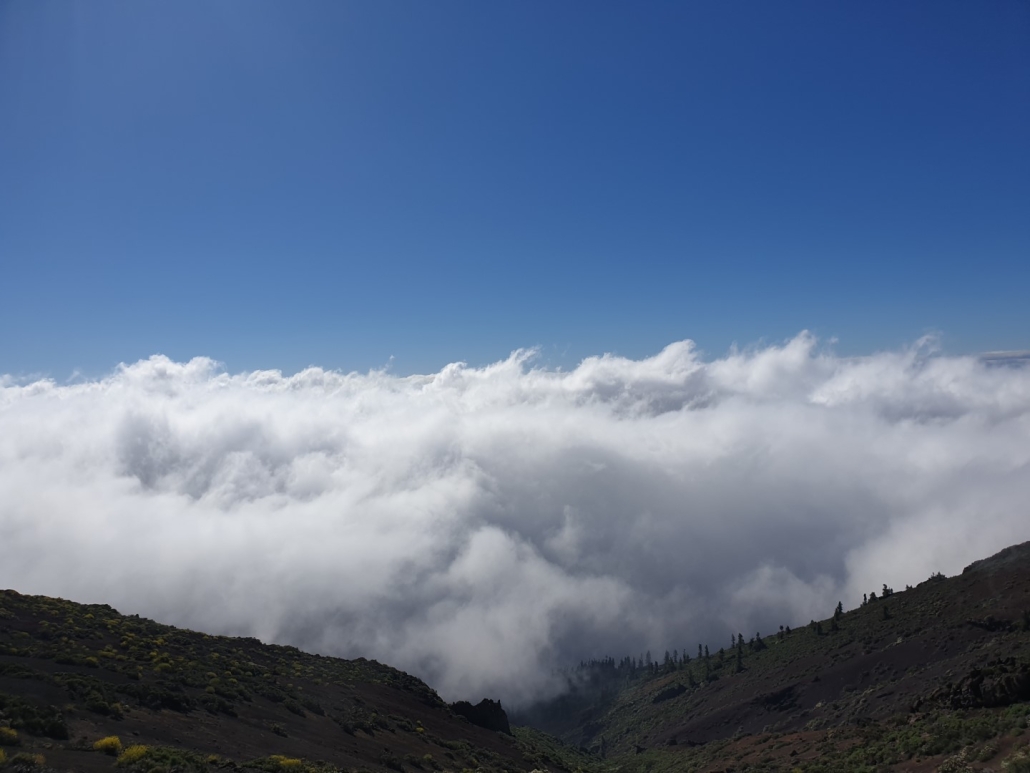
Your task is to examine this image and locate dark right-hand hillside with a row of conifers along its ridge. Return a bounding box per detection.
[513,543,1030,771]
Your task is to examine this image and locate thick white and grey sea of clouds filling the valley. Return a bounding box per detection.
[0,333,1030,704]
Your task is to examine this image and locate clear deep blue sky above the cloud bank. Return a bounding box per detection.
[0,0,1030,378]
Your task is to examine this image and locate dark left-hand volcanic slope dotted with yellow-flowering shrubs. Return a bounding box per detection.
[0,591,585,771]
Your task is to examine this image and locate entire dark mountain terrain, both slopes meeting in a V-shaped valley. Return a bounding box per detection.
[0,543,1030,773]
